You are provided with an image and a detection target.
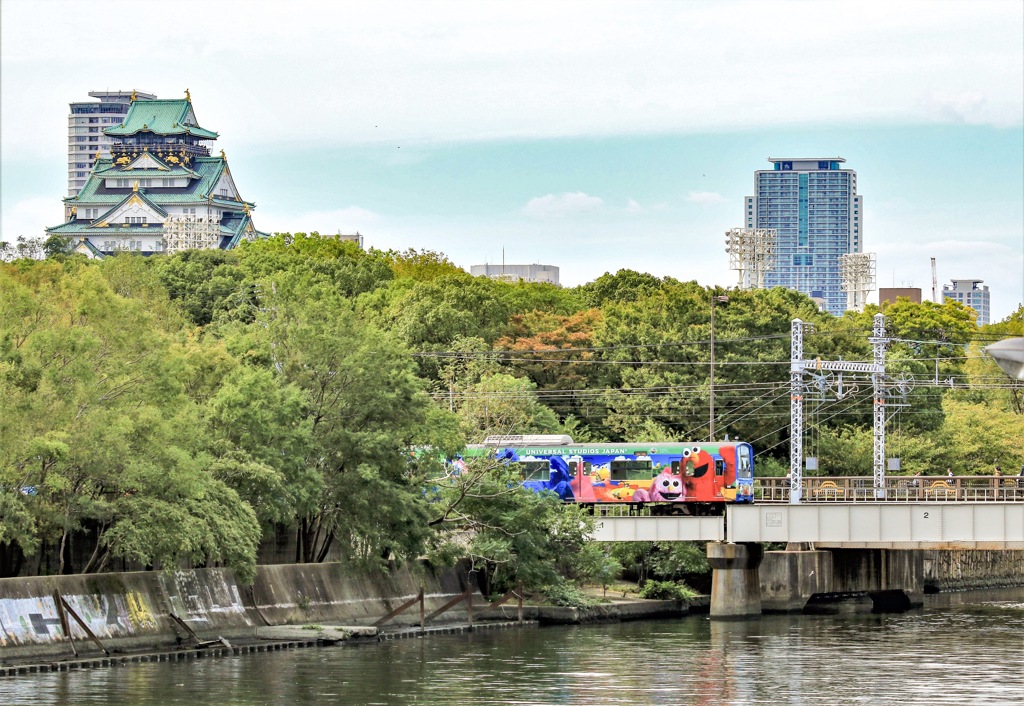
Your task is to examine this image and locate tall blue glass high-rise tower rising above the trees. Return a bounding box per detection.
[743,157,864,316]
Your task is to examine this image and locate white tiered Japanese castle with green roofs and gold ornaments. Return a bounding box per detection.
[46,90,267,257]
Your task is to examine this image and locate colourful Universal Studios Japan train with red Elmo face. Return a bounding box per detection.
[467,435,754,514]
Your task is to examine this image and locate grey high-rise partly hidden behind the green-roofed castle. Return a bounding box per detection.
[68,91,157,197]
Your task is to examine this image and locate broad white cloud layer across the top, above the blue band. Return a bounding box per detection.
[0,0,1024,157]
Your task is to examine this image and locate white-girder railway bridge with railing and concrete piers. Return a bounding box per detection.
[594,476,1024,618]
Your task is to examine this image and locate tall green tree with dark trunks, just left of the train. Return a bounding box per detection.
[235,277,448,563]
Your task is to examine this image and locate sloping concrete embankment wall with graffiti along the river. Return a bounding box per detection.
[0,564,467,660]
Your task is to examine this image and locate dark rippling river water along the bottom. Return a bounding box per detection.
[0,589,1024,706]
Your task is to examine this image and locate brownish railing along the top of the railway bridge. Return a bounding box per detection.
[754,475,1024,502]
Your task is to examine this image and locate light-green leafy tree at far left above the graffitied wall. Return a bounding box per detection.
[0,263,260,577]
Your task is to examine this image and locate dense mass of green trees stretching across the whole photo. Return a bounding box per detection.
[0,234,1024,586]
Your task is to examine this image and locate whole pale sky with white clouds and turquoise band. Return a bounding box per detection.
[6,0,1024,321]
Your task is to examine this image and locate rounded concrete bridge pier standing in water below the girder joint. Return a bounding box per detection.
[708,542,764,620]
